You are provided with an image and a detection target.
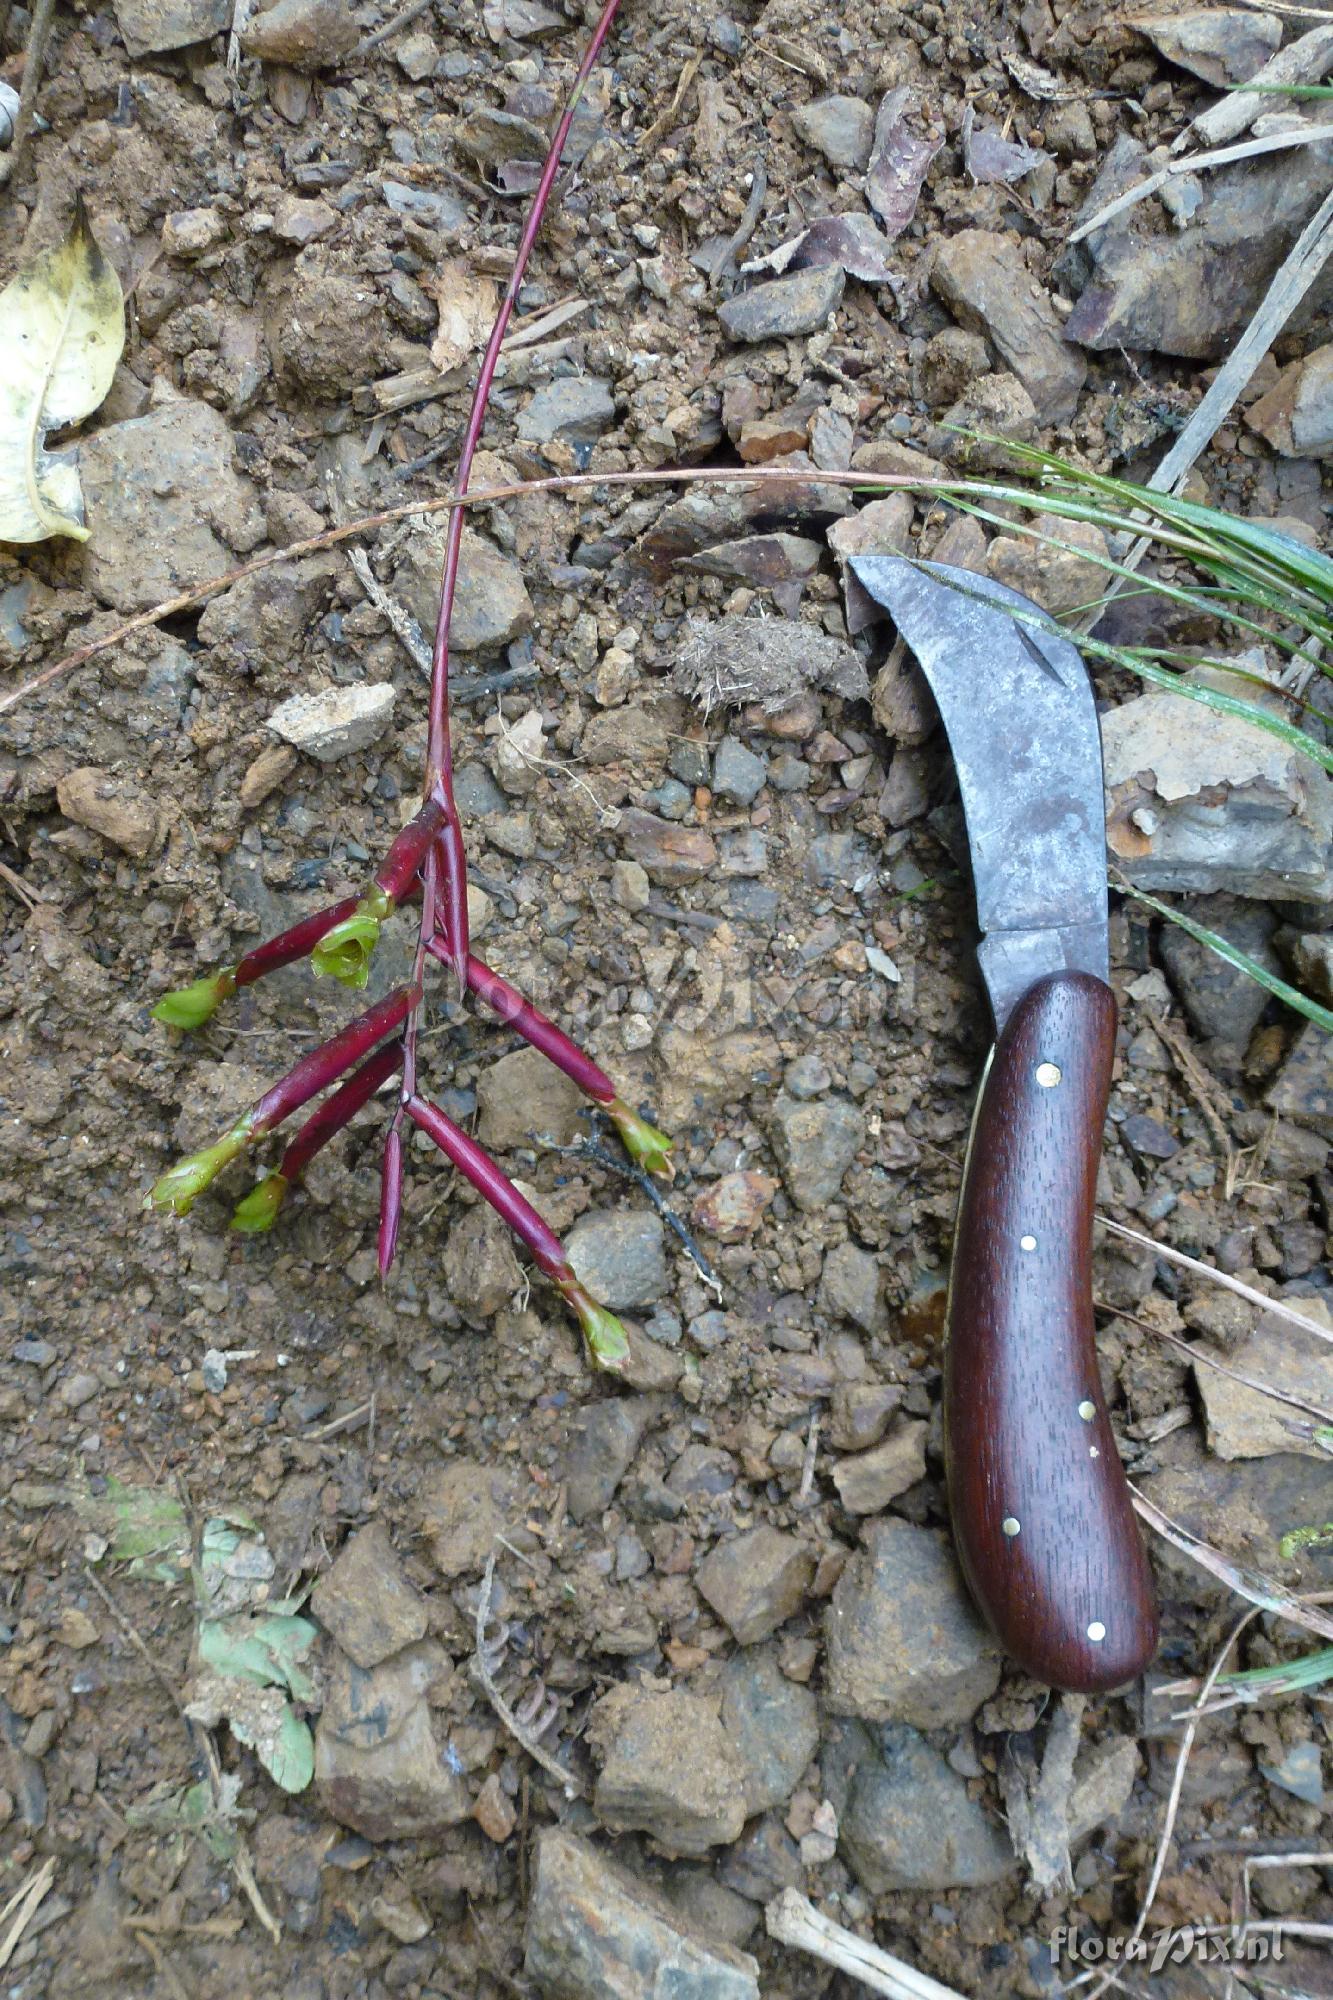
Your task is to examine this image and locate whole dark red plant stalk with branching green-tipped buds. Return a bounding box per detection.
[146,0,671,1368]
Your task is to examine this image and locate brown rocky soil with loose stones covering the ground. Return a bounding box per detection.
[0,0,1333,2000]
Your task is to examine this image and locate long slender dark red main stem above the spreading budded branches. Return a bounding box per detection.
[412,0,620,984]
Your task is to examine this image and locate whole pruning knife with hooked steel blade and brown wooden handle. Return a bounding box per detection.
[851,556,1157,1694]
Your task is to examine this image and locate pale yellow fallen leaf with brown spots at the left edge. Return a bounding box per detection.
[0,202,124,542]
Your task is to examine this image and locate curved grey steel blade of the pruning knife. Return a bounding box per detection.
[851,556,1107,1032]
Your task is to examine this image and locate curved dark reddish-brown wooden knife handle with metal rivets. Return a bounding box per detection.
[945,972,1157,1694]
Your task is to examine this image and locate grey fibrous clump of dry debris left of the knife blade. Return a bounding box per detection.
[671,618,871,714]
